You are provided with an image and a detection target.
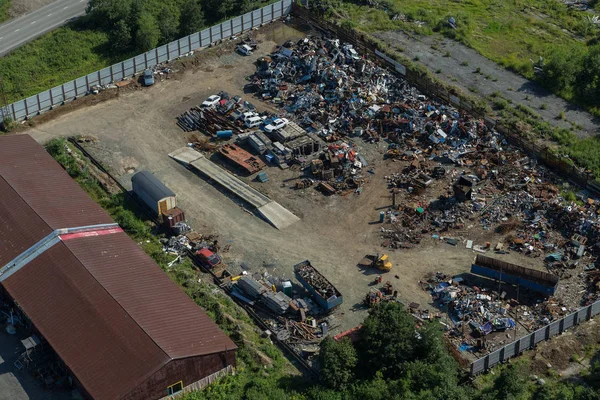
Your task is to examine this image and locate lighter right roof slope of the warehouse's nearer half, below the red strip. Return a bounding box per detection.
[65,233,236,358]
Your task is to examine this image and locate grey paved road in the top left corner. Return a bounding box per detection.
[0,0,88,56]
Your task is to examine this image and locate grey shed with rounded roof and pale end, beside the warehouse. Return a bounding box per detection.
[131,171,177,215]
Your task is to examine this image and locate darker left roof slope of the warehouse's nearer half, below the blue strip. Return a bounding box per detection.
[3,243,169,400]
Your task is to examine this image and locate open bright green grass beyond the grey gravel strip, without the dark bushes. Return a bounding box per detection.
[329,0,597,77]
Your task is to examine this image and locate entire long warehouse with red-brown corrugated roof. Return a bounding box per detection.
[0,135,236,400]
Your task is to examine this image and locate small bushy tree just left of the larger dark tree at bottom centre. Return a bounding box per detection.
[319,338,358,390]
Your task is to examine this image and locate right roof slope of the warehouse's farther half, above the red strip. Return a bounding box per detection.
[0,135,113,230]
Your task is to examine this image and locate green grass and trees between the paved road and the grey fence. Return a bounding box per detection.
[0,0,270,101]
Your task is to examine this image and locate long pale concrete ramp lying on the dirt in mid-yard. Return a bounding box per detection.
[169,147,300,229]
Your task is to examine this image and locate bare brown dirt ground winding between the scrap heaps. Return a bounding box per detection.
[28,23,542,330]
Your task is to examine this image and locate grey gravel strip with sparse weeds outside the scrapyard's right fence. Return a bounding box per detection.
[375,31,600,137]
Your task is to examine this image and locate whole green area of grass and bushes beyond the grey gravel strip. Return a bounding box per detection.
[321,0,600,109]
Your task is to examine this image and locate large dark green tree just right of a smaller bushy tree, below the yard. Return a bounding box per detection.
[359,303,416,377]
